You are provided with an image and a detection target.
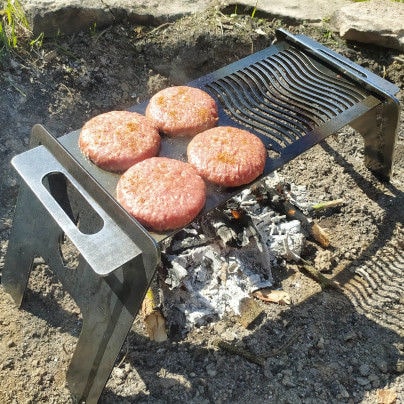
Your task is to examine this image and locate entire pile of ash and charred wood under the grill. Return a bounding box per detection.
[157,173,316,334]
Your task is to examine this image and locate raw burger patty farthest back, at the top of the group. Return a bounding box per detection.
[146,86,218,136]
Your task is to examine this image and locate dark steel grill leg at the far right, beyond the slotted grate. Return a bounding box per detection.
[350,99,400,181]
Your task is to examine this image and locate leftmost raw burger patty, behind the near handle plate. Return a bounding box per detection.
[79,111,161,172]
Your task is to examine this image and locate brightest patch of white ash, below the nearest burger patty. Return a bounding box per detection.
[165,243,272,329]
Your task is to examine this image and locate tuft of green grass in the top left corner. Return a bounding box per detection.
[0,0,29,52]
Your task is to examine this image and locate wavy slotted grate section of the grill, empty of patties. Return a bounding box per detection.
[206,49,368,153]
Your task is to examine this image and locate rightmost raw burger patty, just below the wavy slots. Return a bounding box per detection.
[187,126,266,187]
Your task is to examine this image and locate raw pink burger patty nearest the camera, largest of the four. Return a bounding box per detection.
[116,157,206,232]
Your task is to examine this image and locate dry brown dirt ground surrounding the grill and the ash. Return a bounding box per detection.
[0,3,404,403]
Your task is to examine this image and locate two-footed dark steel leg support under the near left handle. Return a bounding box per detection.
[2,184,150,403]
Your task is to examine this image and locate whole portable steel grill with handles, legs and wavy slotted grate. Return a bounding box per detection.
[2,30,399,402]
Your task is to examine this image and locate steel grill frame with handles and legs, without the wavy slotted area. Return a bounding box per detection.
[2,30,400,403]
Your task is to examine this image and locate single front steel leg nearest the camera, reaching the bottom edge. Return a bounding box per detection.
[67,259,148,403]
